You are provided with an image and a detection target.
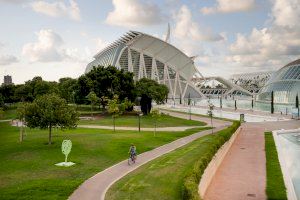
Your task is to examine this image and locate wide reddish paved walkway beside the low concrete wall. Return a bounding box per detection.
[204,120,300,200]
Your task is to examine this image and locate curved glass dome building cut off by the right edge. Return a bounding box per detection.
[258,59,300,104]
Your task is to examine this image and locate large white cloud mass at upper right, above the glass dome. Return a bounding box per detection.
[228,0,300,69]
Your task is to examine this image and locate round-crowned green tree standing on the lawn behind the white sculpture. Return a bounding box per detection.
[25,94,78,144]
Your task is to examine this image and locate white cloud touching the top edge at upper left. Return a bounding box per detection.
[30,0,81,21]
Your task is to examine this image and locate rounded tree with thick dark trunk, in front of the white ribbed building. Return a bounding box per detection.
[136,78,169,115]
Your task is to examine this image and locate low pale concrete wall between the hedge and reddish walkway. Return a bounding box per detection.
[198,127,242,198]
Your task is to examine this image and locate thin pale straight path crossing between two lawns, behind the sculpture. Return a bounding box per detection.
[77,125,203,131]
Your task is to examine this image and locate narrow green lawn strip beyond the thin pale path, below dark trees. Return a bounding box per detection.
[79,115,206,127]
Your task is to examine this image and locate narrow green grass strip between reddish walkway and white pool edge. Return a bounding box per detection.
[265,132,287,200]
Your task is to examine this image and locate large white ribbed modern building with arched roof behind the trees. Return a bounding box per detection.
[85,30,205,99]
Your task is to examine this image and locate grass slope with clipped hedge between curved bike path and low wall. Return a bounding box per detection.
[106,122,240,200]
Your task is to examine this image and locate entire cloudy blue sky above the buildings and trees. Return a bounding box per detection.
[0,0,300,83]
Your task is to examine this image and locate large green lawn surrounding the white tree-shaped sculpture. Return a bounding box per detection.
[0,122,207,200]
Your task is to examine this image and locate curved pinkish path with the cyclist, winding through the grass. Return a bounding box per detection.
[69,111,231,200]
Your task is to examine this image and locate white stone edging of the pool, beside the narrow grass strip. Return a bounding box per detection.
[272,128,300,200]
